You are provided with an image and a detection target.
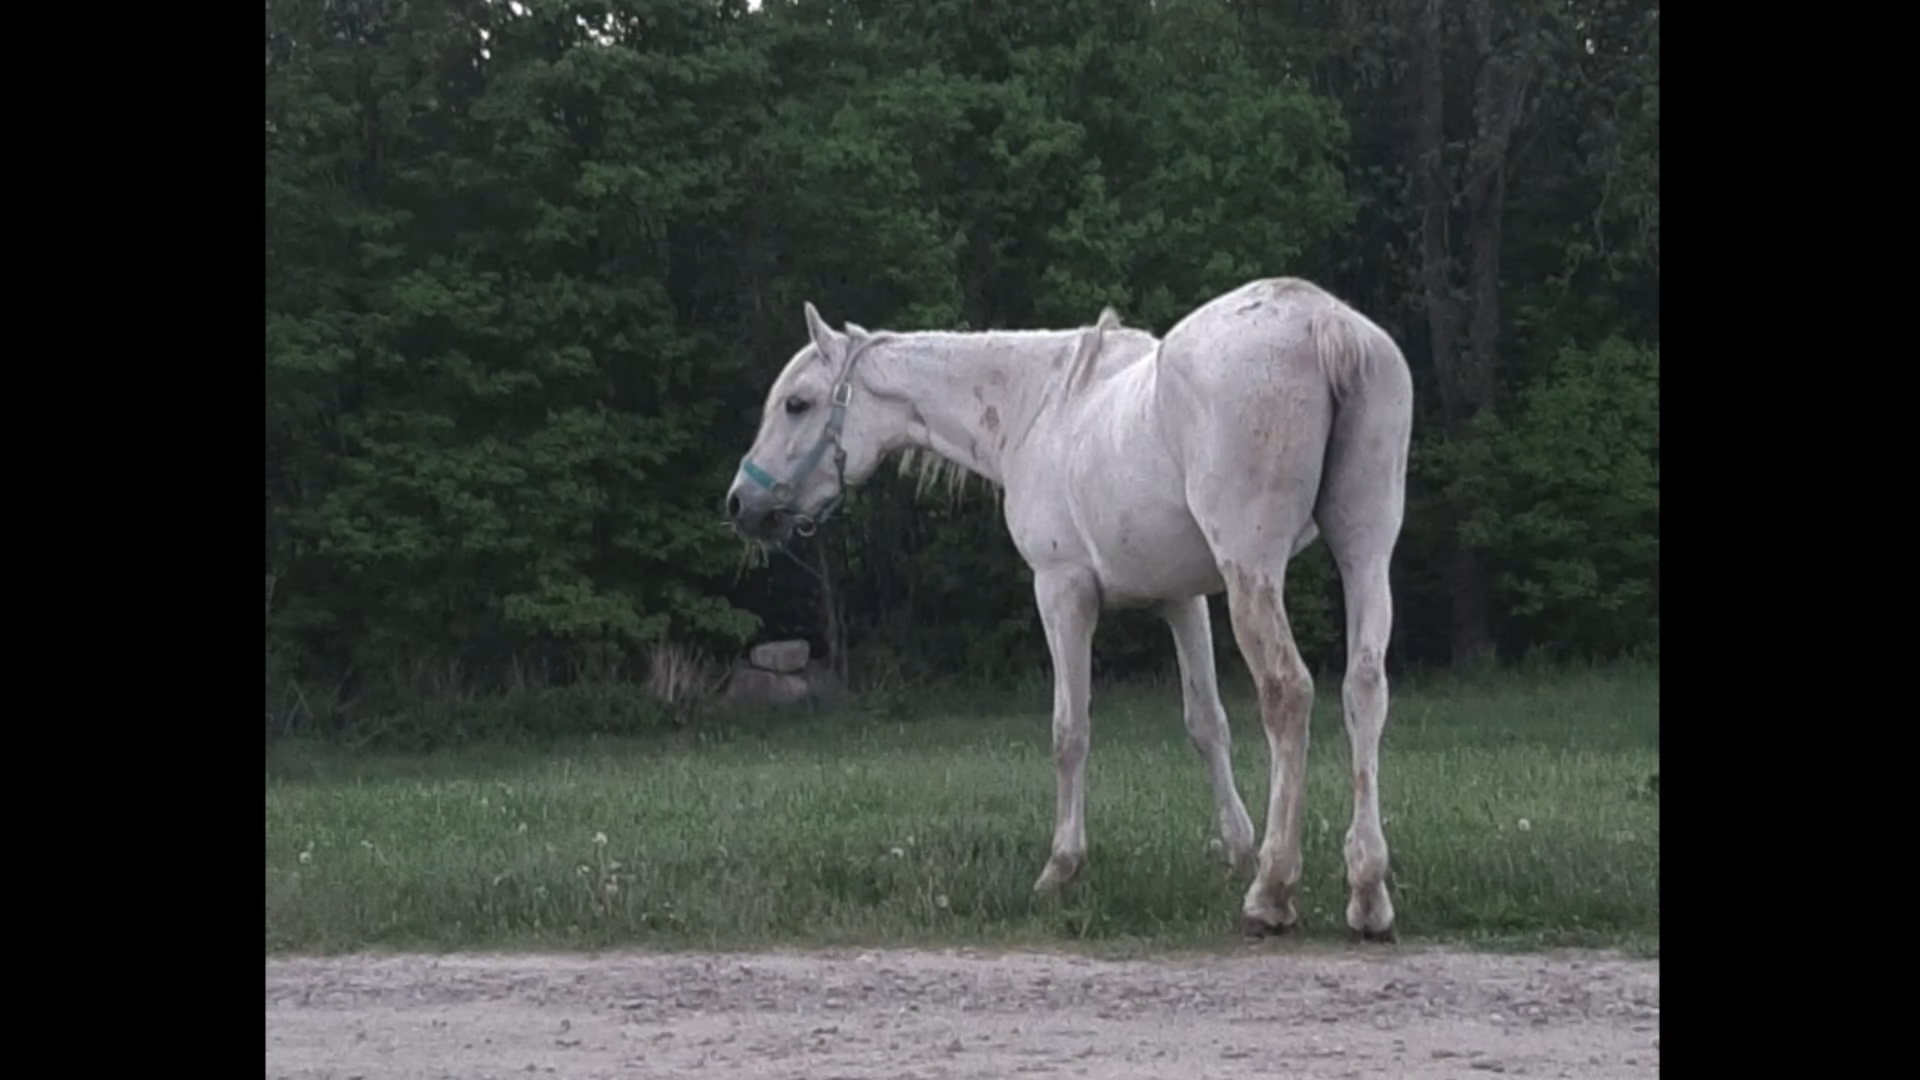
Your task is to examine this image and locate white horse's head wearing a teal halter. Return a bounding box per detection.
[726,304,910,544]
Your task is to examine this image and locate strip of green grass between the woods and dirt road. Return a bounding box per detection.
[267,669,1661,953]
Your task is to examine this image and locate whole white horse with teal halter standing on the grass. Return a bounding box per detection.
[726,279,1413,940]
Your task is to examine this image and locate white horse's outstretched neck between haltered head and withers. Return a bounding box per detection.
[887,332,1068,484]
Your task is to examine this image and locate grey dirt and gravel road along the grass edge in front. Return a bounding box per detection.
[267,945,1661,1080]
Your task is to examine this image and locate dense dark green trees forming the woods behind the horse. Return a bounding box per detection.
[265,0,1659,730]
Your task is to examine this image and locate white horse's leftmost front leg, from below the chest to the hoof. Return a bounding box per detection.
[1033,567,1100,892]
